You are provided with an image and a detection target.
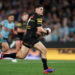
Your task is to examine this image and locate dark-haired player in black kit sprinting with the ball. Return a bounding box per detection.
[0,5,55,74]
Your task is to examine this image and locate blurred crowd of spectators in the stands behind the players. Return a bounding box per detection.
[0,0,75,42]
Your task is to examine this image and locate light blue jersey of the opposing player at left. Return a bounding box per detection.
[0,20,14,38]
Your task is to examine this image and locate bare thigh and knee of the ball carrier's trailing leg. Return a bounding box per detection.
[16,45,29,59]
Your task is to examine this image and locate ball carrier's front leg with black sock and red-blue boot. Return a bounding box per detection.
[34,42,55,73]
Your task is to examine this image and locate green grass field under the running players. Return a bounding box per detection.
[0,60,75,75]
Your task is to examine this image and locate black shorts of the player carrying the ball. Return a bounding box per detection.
[23,38,39,48]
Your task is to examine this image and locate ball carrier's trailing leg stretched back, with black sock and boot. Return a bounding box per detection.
[1,45,29,59]
